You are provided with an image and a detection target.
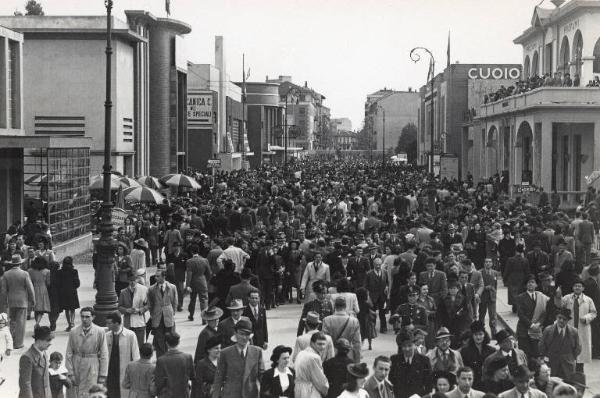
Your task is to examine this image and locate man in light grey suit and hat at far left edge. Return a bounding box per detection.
[0,254,35,350]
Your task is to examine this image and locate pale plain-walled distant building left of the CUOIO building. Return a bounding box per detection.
[365,89,419,152]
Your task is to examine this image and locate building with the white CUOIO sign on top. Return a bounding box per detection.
[417,64,521,180]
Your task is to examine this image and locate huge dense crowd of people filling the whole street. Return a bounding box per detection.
[0,157,600,398]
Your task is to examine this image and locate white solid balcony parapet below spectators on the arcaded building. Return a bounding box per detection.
[478,87,600,119]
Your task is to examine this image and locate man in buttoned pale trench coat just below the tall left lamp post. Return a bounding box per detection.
[65,307,108,398]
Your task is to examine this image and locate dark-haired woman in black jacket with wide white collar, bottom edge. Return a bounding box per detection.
[260,345,296,398]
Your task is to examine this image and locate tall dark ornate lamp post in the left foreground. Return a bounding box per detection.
[94,0,117,326]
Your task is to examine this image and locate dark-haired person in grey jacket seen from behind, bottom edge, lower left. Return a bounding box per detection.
[121,343,155,398]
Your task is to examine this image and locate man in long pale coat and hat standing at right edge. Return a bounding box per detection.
[561,278,597,372]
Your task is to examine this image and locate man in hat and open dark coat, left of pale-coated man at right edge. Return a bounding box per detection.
[516,274,550,358]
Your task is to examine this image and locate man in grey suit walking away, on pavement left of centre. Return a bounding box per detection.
[185,245,212,321]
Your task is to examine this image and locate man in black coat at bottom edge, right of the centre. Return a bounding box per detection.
[389,332,431,398]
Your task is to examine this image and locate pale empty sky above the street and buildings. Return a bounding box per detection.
[0,0,554,129]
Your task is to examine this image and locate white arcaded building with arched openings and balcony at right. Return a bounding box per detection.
[470,0,600,197]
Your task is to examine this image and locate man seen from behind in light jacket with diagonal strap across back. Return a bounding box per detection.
[323,297,362,363]
